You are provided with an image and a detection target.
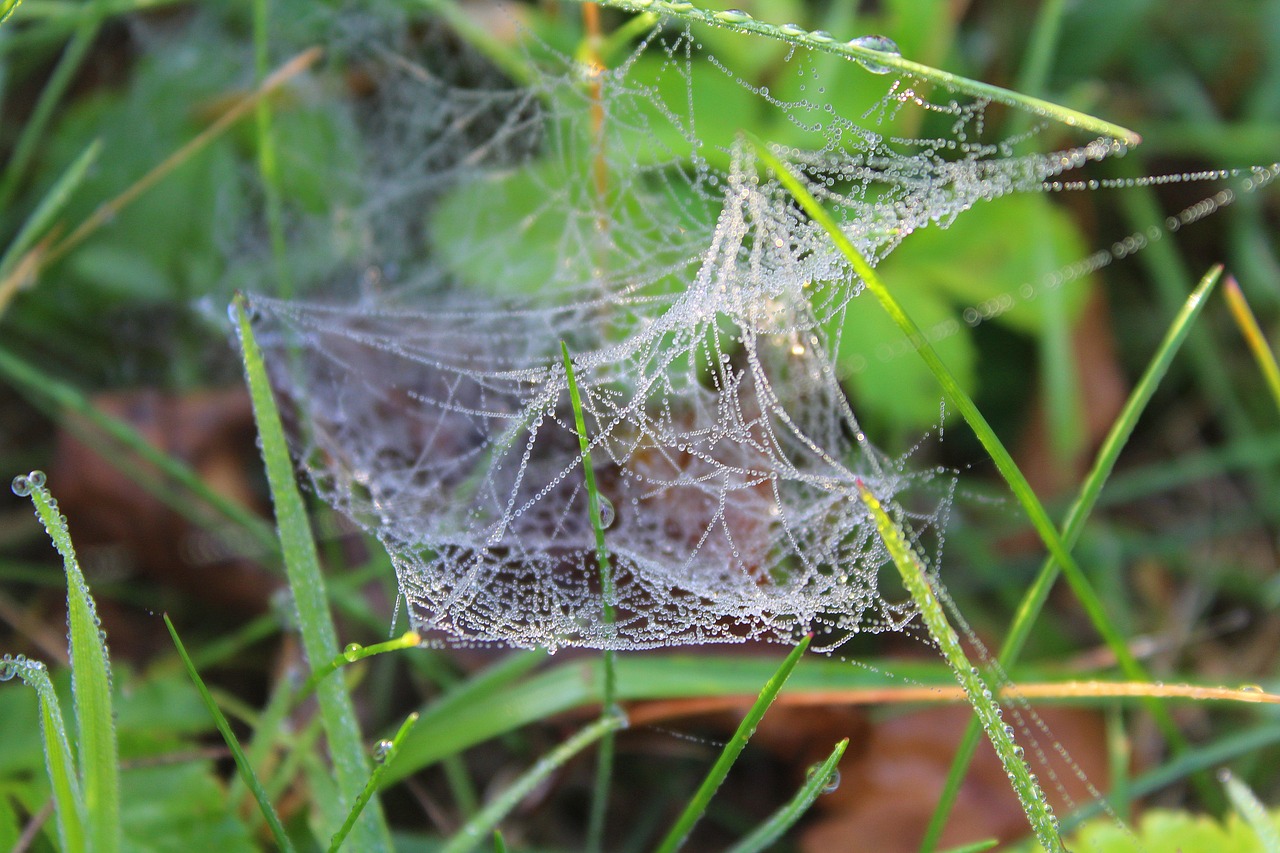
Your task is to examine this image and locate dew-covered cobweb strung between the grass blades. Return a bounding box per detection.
[240,3,1117,649]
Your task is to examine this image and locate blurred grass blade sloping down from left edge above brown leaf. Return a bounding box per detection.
[0,347,280,553]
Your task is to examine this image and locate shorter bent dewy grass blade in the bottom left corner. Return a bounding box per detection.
[0,654,88,853]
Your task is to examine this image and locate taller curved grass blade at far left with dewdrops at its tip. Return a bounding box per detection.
[13,471,120,853]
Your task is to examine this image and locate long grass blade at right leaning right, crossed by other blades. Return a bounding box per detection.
[920,266,1222,850]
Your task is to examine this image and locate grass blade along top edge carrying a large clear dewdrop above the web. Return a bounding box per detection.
[576,0,1142,145]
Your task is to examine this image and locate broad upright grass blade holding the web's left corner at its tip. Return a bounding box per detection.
[233,295,392,852]
